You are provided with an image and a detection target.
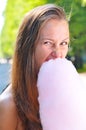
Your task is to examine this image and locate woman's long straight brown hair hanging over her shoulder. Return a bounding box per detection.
[12,4,66,130]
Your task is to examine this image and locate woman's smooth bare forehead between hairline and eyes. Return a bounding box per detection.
[39,19,69,39]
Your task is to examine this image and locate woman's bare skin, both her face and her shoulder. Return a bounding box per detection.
[0,19,69,130]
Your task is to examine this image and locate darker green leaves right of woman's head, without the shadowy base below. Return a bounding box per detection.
[70,0,86,54]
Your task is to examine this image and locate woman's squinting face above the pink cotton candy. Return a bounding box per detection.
[35,19,69,70]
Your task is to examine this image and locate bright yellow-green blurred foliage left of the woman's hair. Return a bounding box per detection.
[1,0,46,57]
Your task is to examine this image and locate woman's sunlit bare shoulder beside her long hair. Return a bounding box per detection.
[0,87,17,130]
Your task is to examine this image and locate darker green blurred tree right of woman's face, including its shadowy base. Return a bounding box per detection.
[69,0,86,70]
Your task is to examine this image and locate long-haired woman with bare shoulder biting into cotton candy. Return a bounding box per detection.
[0,4,69,130]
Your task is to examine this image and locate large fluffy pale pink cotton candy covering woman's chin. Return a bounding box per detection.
[37,58,86,130]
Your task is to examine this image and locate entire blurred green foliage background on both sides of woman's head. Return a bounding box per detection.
[0,0,86,72]
